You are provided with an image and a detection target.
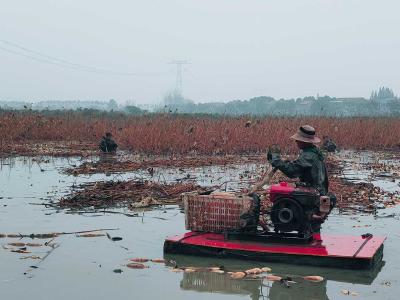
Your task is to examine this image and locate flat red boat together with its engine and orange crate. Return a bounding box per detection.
[164,182,386,269]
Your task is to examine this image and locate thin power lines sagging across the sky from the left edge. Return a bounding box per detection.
[0,40,160,76]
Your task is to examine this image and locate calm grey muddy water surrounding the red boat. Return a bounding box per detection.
[0,158,400,300]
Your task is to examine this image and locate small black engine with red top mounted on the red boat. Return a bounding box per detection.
[269,182,336,235]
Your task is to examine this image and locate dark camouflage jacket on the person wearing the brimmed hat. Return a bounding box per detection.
[271,145,329,195]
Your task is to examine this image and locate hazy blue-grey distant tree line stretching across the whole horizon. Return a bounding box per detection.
[0,87,400,117]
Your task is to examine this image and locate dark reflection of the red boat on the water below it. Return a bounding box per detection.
[165,254,384,300]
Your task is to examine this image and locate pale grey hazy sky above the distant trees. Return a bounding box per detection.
[0,0,400,104]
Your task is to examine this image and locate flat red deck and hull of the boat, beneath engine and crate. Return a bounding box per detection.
[164,232,386,268]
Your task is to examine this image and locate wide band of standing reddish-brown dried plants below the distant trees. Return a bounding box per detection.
[0,112,400,155]
